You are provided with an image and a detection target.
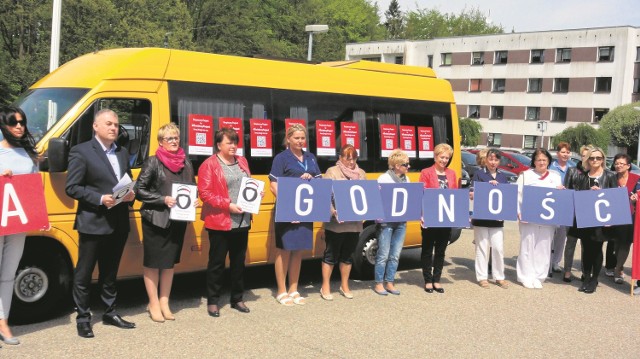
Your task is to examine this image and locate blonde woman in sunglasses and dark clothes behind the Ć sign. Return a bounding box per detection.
[575,147,618,293]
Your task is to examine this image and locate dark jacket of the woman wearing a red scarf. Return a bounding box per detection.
[135,156,196,228]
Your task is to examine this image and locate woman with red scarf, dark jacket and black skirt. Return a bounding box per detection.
[135,123,197,323]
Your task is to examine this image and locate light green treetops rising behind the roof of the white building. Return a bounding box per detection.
[405,8,504,40]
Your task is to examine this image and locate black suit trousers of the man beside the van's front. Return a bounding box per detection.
[72,231,128,323]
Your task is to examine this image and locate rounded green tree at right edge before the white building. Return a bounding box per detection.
[600,102,640,147]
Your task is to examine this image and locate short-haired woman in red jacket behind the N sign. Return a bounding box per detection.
[420,143,458,293]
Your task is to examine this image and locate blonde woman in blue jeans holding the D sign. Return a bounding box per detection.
[373,149,411,295]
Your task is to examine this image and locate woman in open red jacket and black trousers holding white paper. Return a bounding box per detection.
[198,128,264,317]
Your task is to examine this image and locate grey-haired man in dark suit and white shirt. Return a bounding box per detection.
[66,109,135,338]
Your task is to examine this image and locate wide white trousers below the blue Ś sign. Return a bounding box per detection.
[516,222,555,283]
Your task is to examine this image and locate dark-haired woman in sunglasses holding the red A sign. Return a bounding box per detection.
[0,107,38,345]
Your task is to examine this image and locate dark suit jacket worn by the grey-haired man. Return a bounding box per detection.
[65,137,131,235]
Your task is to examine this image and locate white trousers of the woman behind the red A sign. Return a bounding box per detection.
[0,233,26,319]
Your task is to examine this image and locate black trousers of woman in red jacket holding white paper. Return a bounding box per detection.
[207,228,249,305]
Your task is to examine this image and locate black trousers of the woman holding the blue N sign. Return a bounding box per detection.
[420,228,451,284]
